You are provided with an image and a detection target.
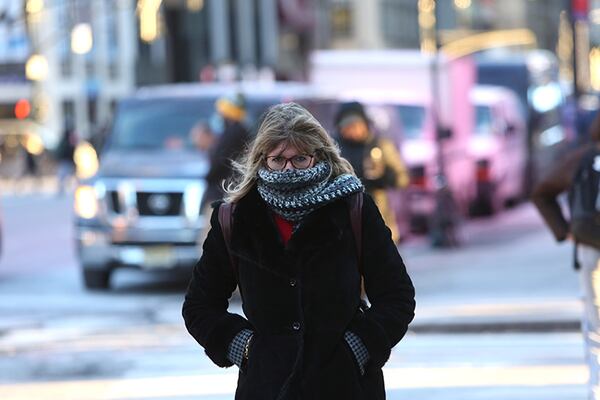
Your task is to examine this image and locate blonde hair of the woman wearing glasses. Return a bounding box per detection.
[224,103,354,202]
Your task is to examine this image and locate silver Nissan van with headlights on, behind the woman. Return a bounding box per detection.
[75,84,332,289]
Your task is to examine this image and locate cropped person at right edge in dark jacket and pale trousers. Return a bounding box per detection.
[532,112,600,399]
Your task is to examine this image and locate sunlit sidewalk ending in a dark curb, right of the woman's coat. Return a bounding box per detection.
[400,204,583,333]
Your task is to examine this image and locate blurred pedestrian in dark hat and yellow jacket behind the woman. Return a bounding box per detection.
[335,102,409,243]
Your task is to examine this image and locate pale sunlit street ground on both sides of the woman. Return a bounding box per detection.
[0,195,587,400]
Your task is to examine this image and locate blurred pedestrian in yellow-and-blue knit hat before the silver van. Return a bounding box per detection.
[202,94,250,209]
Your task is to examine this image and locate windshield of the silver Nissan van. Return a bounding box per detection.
[109,99,215,150]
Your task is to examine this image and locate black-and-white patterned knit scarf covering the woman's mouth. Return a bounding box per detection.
[257,161,364,222]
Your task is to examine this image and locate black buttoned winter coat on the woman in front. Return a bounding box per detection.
[183,189,415,400]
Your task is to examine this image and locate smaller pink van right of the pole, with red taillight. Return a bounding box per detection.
[468,85,527,215]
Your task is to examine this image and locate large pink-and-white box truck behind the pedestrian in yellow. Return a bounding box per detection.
[310,50,476,231]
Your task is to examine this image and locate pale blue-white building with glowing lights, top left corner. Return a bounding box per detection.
[0,0,136,149]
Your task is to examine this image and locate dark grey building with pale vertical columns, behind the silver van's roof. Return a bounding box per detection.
[137,0,316,84]
